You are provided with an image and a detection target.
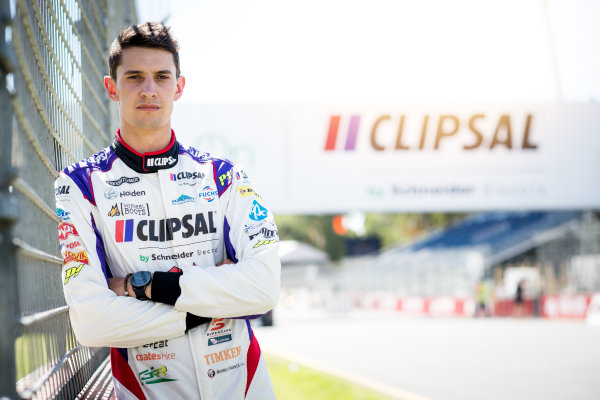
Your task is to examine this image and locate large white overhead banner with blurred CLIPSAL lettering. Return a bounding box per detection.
[174,104,600,213]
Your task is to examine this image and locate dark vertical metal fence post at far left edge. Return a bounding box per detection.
[0,0,19,400]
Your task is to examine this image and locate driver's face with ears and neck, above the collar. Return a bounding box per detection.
[104,47,185,134]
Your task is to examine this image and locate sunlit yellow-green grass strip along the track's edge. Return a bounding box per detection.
[265,354,392,400]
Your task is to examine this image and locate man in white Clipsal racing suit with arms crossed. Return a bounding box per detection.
[55,23,281,400]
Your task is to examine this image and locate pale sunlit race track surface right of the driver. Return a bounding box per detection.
[255,308,600,400]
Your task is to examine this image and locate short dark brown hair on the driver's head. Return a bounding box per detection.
[108,22,181,80]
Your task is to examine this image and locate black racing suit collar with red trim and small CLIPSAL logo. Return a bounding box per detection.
[112,129,179,174]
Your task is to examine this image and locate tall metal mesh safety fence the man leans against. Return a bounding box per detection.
[0,0,137,400]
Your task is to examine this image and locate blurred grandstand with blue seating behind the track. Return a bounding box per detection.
[332,211,600,310]
